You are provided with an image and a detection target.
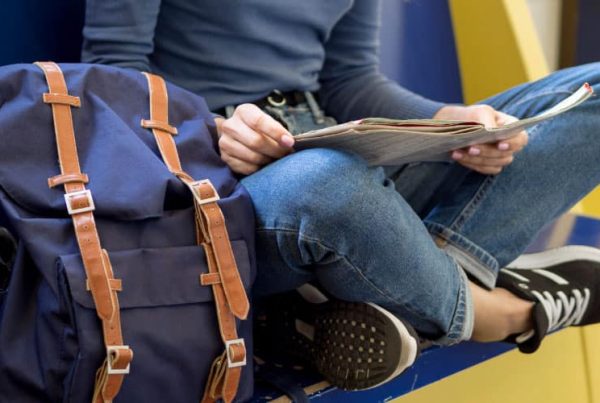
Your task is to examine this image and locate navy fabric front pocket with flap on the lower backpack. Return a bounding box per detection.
[58,241,251,403]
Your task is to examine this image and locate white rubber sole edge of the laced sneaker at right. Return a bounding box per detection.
[506,245,600,269]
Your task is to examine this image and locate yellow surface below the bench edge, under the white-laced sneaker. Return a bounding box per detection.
[394,329,600,403]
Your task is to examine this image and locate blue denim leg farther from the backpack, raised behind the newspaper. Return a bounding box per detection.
[425,63,600,288]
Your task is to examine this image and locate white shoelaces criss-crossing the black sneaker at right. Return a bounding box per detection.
[532,288,591,332]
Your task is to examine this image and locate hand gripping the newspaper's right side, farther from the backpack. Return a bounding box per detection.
[433,105,528,175]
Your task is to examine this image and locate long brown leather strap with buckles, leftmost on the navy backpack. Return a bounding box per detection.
[35,62,133,403]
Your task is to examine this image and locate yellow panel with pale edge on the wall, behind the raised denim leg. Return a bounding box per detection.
[449,0,549,103]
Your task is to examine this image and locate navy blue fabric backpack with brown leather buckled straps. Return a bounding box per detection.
[0,62,255,403]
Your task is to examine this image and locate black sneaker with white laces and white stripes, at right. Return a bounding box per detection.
[497,246,600,353]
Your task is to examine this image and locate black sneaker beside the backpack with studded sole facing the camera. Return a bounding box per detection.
[255,284,419,390]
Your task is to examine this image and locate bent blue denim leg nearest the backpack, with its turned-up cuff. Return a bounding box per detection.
[242,149,472,344]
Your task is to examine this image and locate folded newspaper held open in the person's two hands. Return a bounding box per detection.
[295,83,593,165]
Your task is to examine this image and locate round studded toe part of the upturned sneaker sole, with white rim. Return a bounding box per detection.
[313,301,419,390]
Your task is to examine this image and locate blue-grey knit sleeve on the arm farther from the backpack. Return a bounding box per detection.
[319,0,445,122]
